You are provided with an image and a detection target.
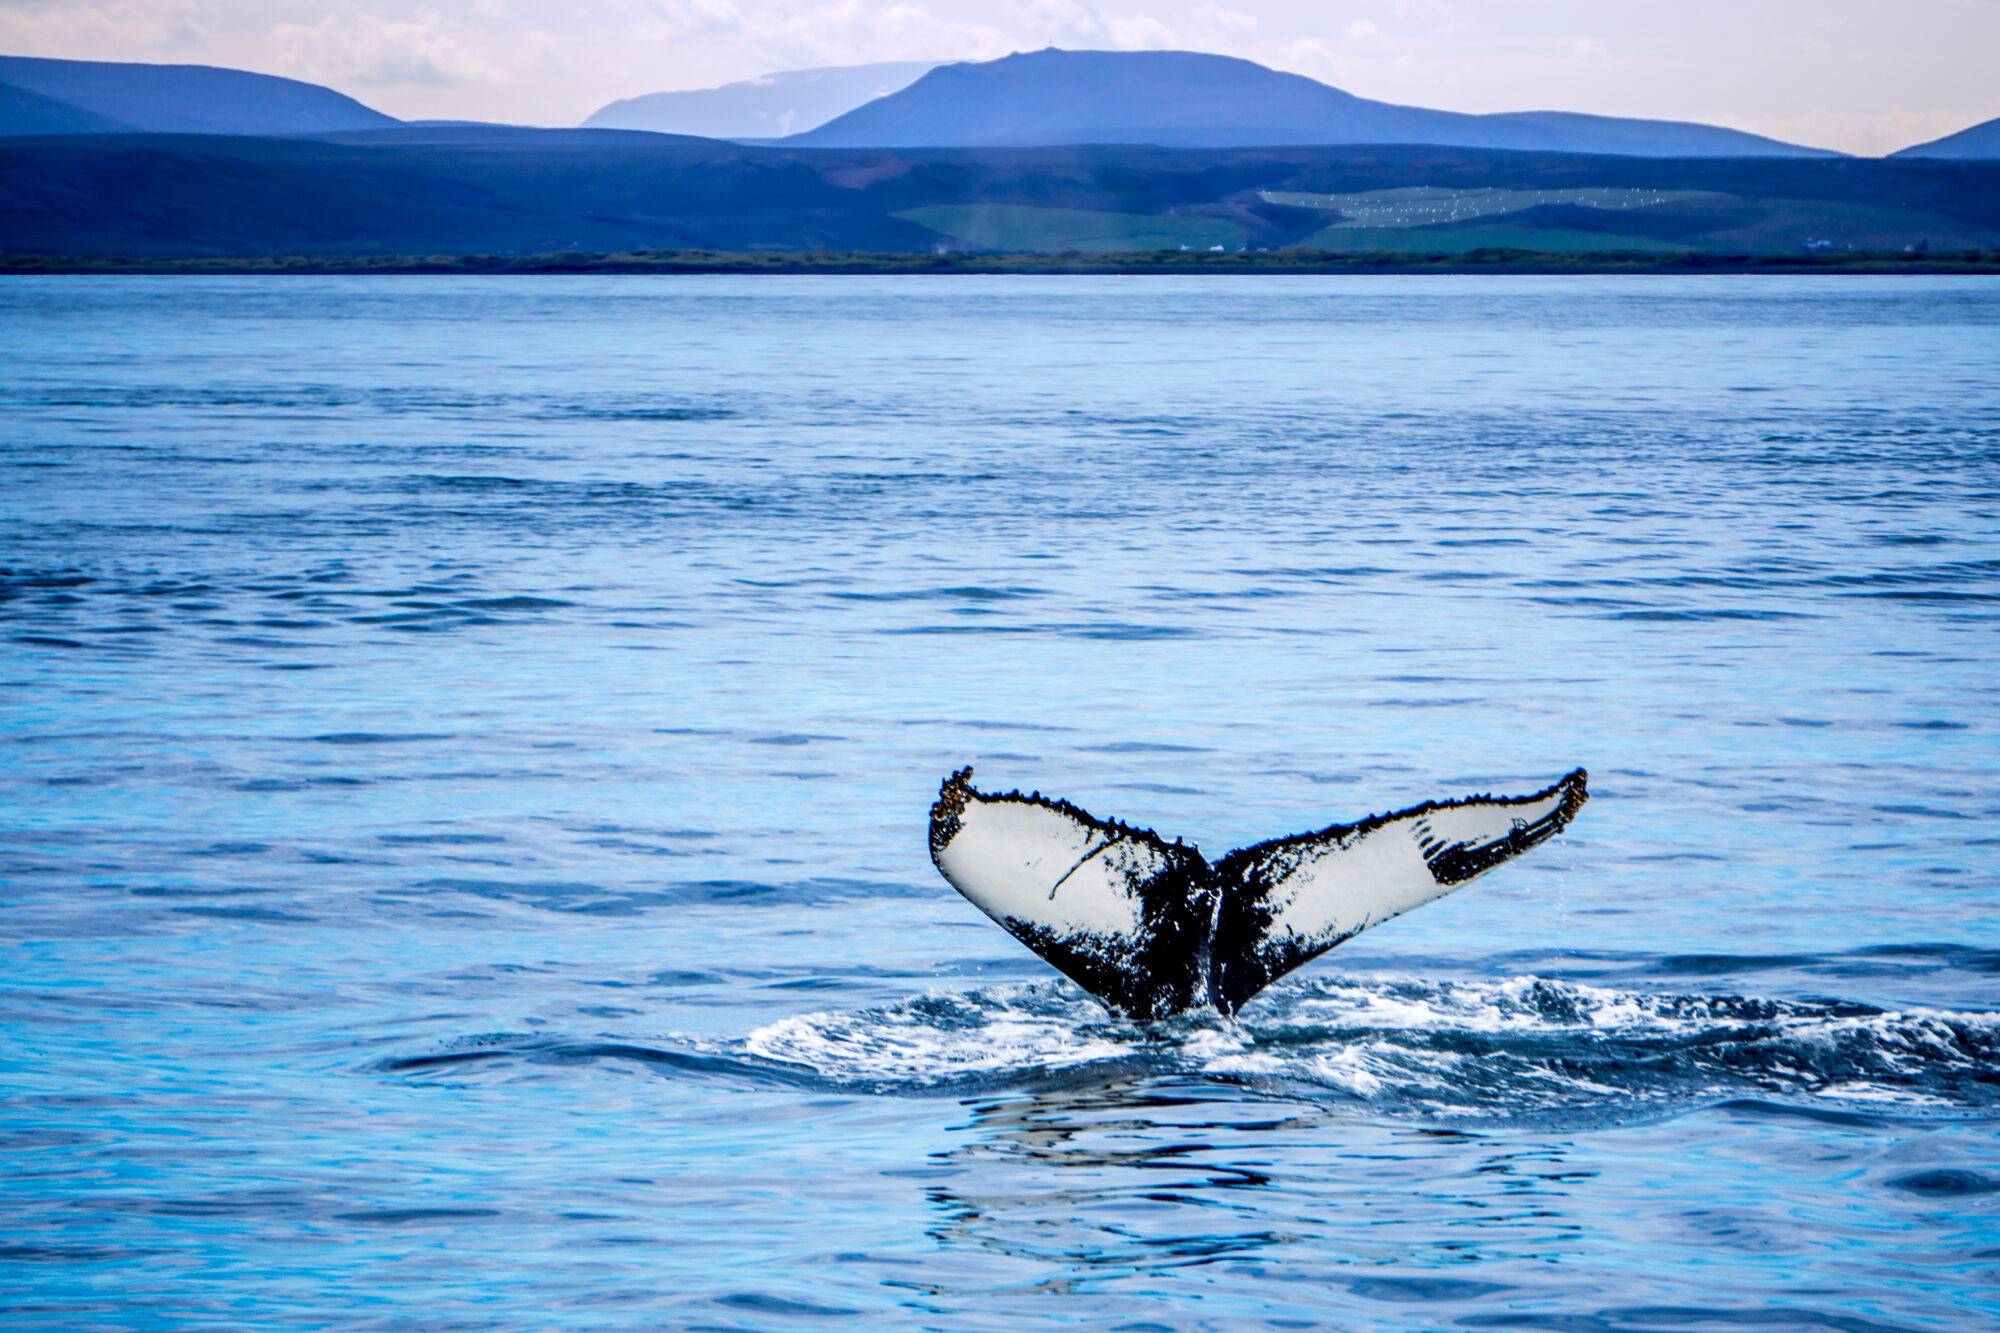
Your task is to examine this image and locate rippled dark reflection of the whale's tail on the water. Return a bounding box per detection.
[930,1079,1594,1289]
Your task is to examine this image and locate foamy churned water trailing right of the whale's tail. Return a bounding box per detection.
[1202,977,2000,1117]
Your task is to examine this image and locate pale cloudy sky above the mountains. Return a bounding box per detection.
[0,0,2000,152]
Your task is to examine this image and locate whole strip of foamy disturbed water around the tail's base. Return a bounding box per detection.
[378,977,2000,1121]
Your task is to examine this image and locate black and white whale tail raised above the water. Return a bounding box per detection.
[930,769,1588,1019]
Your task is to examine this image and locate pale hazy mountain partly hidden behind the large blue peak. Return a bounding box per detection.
[584,60,936,138]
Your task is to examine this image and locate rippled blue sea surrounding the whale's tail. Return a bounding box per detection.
[0,276,2000,1333]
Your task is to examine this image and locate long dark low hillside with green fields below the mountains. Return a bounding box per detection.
[0,137,2000,270]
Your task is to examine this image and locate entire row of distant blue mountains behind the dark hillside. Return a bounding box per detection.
[0,48,2000,158]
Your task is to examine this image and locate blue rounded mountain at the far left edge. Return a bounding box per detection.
[0,56,400,134]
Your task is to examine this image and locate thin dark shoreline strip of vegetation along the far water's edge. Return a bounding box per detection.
[0,248,2000,276]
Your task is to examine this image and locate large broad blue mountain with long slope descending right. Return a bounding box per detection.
[784,48,1840,158]
